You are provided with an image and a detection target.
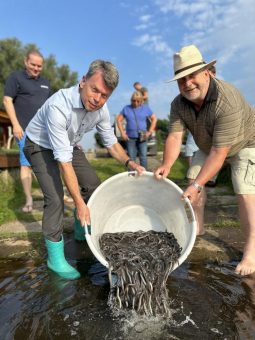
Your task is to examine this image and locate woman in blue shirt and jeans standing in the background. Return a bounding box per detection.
[116,91,157,169]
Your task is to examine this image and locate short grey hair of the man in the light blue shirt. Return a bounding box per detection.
[86,59,119,91]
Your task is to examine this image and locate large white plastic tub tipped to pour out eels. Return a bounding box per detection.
[85,172,196,269]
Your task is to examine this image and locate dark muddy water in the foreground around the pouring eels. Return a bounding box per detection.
[0,235,255,340]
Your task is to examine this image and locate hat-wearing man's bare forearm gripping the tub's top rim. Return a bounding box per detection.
[154,131,183,179]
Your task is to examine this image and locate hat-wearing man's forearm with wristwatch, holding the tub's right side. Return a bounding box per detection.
[183,146,230,201]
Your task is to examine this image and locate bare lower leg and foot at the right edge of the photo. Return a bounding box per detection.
[235,195,255,276]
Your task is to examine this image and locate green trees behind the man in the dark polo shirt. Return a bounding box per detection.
[0,38,78,110]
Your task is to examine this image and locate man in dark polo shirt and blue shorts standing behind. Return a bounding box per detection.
[3,50,51,212]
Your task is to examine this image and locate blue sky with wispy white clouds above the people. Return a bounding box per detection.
[0,0,255,149]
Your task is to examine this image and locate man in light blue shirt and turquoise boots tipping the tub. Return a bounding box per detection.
[24,60,145,279]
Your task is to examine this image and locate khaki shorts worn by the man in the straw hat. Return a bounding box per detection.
[187,148,255,195]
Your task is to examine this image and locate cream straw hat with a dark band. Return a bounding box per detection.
[168,45,216,82]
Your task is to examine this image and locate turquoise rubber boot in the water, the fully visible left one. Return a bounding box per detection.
[45,236,81,280]
